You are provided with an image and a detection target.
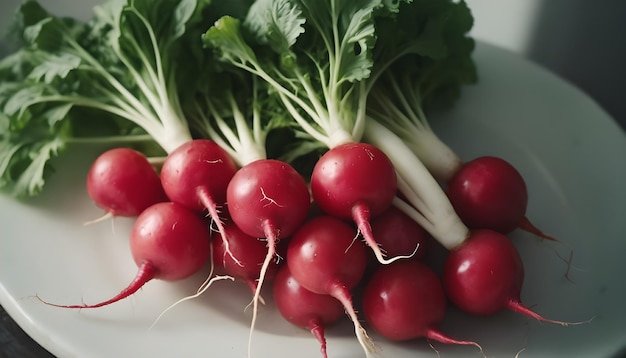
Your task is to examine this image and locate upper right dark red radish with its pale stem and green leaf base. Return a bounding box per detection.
[367,65,558,246]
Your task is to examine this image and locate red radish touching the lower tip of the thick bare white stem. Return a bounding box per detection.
[442,229,568,325]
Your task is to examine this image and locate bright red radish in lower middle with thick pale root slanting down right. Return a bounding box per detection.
[287,216,377,357]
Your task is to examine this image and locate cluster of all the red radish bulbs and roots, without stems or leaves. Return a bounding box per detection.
[37,131,576,356]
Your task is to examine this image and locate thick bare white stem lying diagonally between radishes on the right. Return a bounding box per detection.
[363,119,469,250]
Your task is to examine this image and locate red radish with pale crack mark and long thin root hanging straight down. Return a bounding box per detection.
[226,159,311,355]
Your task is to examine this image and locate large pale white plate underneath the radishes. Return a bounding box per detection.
[0,2,626,358]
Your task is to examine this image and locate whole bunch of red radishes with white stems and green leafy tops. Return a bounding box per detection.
[14,0,584,357]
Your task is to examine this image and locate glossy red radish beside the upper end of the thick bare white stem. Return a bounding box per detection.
[311,143,397,263]
